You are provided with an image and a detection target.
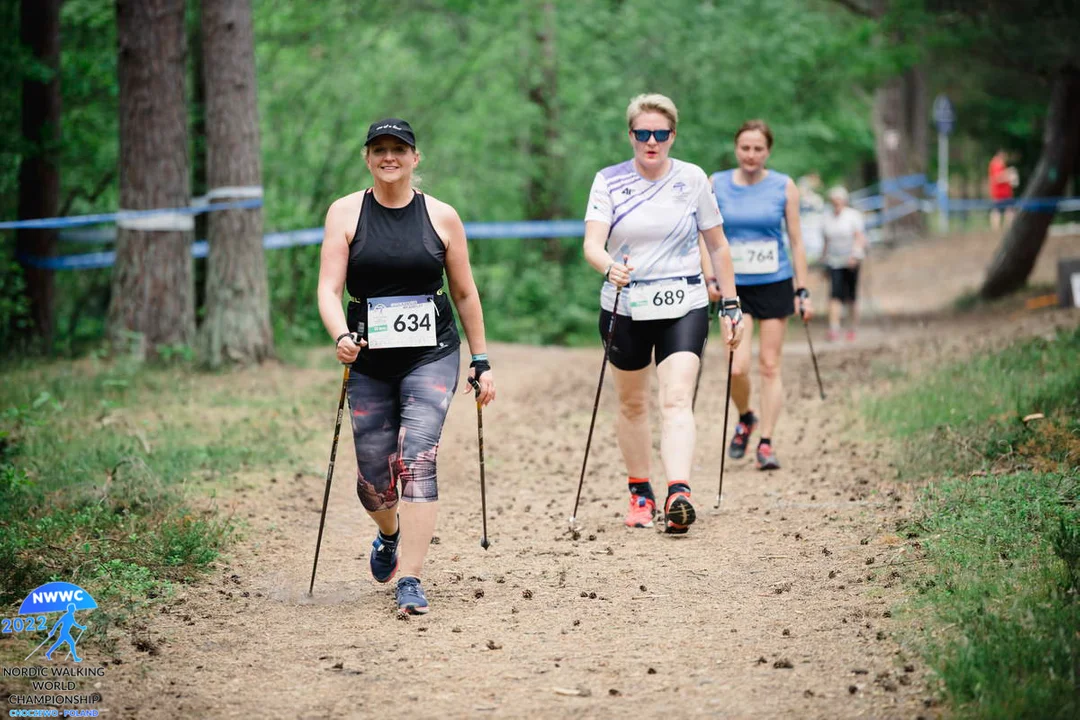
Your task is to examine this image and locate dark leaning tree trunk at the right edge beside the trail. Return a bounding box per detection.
[978,67,1080,299]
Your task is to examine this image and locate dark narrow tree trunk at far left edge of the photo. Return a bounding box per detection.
[15,0,62,351]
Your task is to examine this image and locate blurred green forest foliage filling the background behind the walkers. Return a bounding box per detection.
[0,0,1080,355]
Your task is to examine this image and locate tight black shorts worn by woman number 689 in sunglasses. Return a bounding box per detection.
[599,308,708,370]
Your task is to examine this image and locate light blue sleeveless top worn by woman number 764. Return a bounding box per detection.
[710,169,794,285]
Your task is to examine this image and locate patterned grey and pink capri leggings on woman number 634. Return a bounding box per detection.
[349,353,459,512]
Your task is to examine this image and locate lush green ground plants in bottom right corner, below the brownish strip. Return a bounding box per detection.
[913,473,1080,719]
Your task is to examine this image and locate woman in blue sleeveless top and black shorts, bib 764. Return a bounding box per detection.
[712,120,812,470]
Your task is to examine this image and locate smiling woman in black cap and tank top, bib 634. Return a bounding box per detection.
[319,118,495,614]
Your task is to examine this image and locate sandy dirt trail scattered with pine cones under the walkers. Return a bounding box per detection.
[38,231,1076,718]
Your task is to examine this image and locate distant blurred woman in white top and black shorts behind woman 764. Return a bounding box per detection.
[822,186,866,340]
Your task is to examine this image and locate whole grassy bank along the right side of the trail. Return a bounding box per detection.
[865,328,1080,718]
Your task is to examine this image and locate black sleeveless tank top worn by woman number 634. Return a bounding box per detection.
[345,190,461,380]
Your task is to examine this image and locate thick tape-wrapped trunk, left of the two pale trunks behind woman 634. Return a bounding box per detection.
[108,0,195,358]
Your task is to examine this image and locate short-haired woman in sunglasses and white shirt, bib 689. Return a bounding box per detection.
[584,94,742,533]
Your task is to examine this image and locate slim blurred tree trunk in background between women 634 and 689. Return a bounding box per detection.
[525,0,565,261]
